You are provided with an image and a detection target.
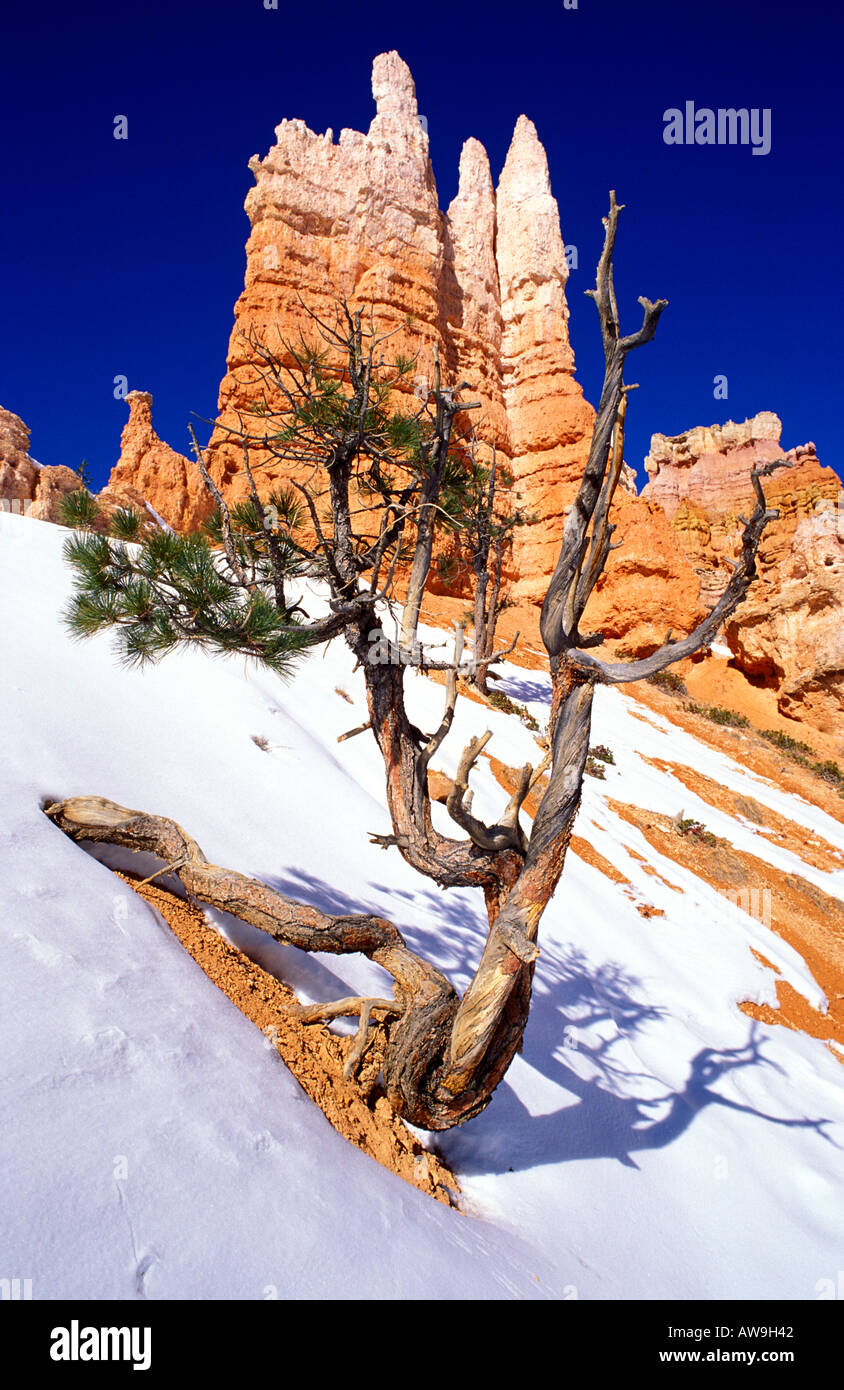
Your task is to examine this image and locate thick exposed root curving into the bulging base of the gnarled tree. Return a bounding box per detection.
[43,785,547,1130]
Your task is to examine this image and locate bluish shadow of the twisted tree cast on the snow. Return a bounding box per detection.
[77,845,838,1176]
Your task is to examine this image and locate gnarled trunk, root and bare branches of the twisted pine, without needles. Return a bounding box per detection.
[46,193,779,1130]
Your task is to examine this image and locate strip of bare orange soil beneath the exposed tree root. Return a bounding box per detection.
[118,873,460,1205]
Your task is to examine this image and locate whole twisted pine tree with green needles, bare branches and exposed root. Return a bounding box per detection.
[44,193,780,1130]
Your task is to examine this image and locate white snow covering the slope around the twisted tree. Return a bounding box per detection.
[0,514,844,1300]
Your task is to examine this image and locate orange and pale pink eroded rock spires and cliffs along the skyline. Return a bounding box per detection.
[66,53,841,739]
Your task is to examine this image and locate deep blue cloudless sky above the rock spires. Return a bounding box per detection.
[0,0,844,485]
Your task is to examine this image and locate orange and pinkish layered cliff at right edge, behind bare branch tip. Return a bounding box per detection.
[642,410,844,734]
